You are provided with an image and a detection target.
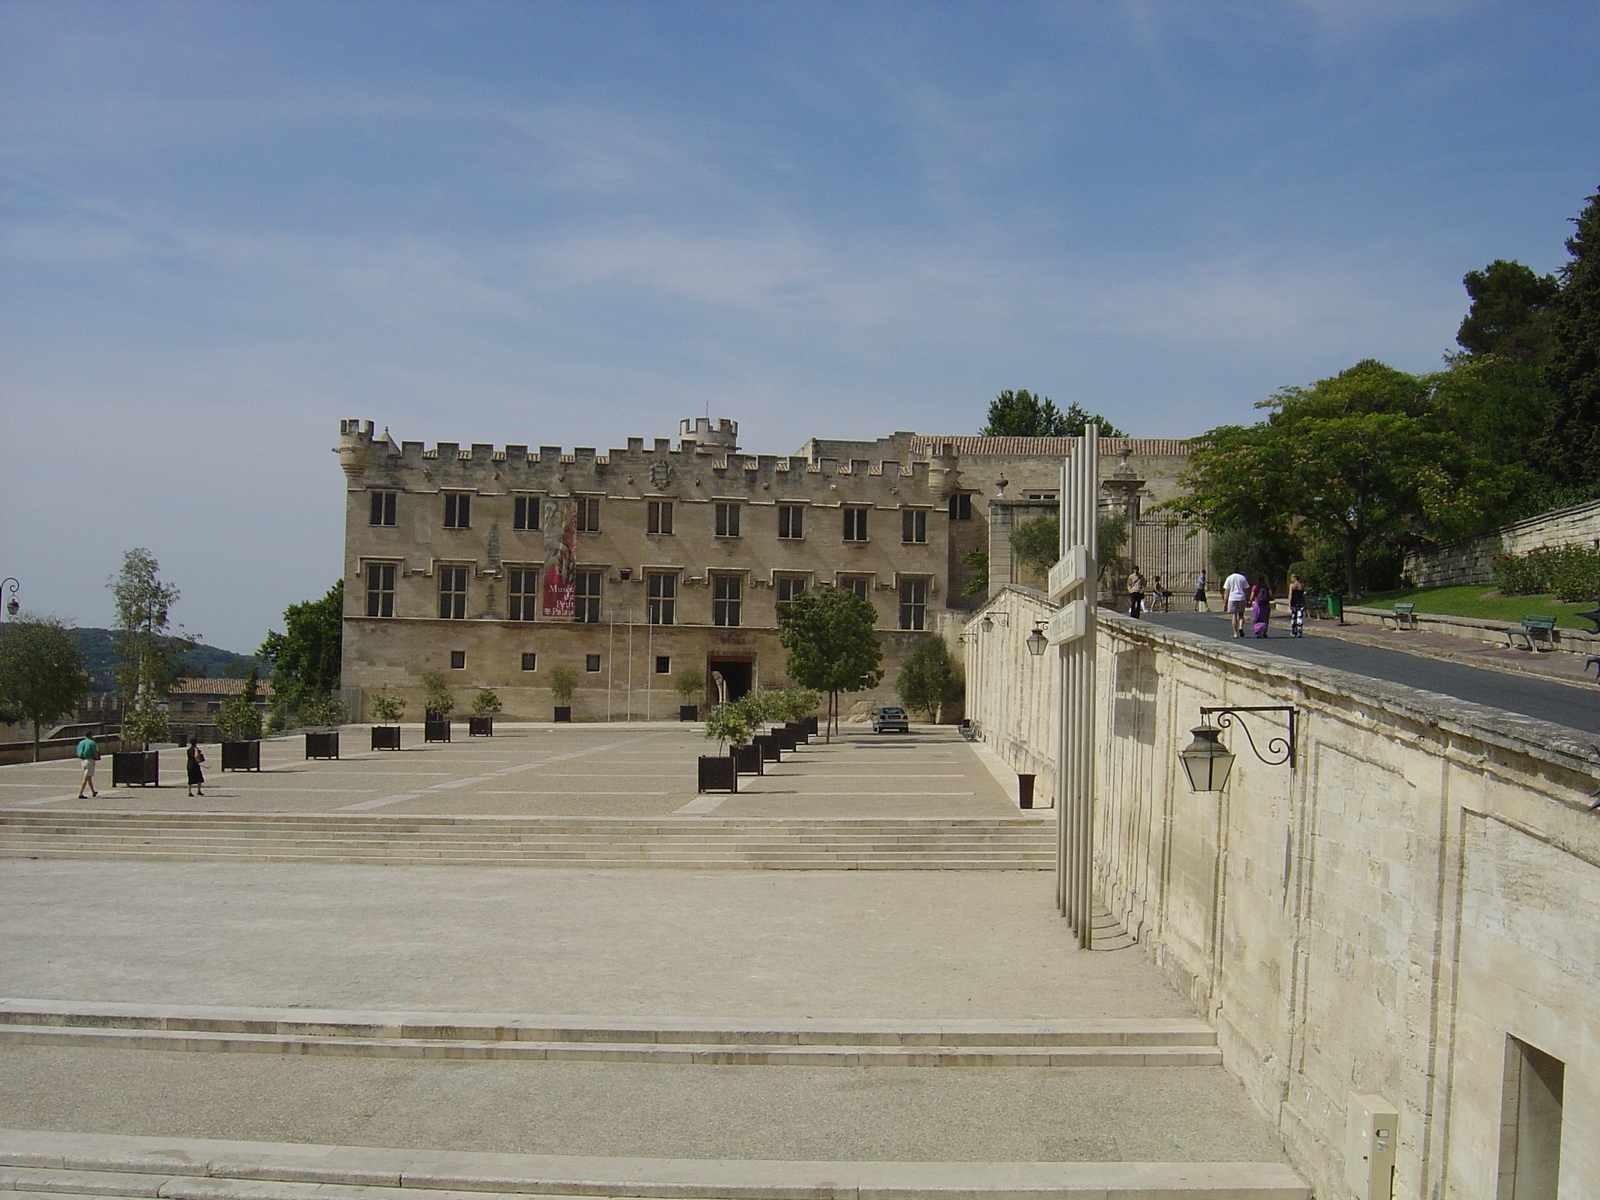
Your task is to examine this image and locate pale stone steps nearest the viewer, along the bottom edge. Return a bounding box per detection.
[0,1130,1310,1200]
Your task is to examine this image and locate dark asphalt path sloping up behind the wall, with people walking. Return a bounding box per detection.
[1144,613,1600,734]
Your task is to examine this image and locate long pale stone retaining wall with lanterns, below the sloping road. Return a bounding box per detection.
[968,592,1600,1200]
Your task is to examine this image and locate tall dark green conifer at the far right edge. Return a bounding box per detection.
[1542,194,1600,483]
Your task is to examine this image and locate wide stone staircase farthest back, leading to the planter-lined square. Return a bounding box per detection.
[0,810,1056,870]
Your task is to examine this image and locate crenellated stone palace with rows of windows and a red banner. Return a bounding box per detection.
[338,418,1186,720]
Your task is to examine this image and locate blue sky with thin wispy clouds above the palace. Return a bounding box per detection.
[0,0,1600,650]
